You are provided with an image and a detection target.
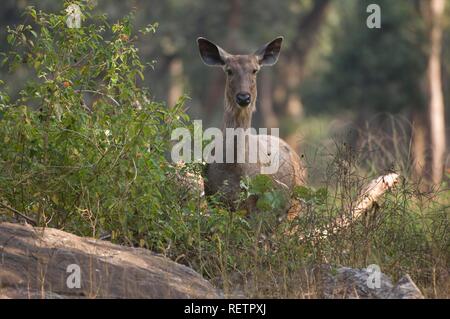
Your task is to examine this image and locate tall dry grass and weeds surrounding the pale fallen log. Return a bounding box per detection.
[172,115,450,298]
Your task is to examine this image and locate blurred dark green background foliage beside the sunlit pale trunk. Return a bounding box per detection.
[302,0,428,118]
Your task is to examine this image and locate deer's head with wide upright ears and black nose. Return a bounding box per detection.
[197,37,283,127]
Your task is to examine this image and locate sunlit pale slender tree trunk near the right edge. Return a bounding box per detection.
[427,0,446,184]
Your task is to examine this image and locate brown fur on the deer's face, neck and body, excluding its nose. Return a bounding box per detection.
[199,40,305,219]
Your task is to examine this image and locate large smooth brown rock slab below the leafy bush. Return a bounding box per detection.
[0,223,221,298]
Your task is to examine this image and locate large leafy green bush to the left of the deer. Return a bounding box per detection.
[0,3,193,250]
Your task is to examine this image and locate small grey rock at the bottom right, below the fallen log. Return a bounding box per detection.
[323,266,424,299]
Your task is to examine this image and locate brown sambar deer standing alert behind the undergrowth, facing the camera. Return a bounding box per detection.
[197,37,305,218]
